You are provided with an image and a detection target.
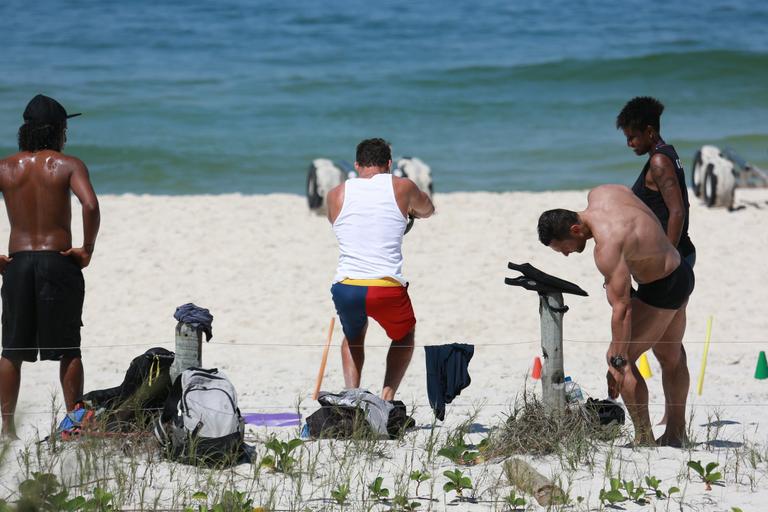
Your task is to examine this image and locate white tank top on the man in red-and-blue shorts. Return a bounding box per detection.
[333,174,407,285]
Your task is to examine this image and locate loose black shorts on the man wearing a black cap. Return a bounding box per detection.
[2,251,85,361]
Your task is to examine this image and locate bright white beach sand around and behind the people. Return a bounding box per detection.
[0,191,768,510]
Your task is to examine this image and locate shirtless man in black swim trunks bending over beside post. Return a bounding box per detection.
[539,185,694,446]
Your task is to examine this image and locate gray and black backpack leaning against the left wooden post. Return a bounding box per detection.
[154,368,245,464]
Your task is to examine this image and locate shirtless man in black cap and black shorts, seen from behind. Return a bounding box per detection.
[0,94,100,438]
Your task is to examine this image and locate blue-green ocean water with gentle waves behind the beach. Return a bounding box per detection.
[0,0,768,194]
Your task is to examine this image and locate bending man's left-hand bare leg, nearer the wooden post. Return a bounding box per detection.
[621,298,675,445]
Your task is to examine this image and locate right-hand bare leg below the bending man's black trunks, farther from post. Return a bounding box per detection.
[653,305,691,447]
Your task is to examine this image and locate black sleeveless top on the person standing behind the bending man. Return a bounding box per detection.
[632,140,696,258]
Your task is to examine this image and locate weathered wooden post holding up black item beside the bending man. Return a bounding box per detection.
[539,293,568,413]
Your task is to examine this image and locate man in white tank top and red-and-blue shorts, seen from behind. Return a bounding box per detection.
[326,139,435,400]
